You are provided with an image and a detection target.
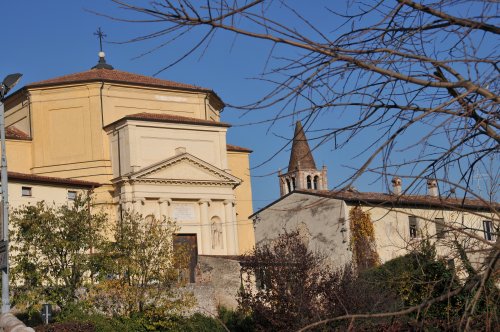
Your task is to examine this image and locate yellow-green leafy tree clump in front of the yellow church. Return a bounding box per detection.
[11,196,194,320]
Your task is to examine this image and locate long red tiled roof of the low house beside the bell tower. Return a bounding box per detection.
[295,190,500,210]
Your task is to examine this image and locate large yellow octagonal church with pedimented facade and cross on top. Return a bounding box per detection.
[0,54,254,256]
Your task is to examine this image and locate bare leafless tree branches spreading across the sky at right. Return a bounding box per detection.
[100,0,500,325]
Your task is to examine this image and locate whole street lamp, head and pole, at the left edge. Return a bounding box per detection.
[0,73,23,314]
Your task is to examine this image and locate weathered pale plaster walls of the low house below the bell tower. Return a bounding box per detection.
[254,193,498,272]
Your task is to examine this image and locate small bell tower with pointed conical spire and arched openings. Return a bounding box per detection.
[278,121,328,196]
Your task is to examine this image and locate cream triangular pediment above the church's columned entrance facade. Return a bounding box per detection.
[129,153,241,186]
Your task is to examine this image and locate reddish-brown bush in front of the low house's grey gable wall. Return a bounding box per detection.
[239,232,326,331]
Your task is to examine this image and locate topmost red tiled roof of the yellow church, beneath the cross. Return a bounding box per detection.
[26,68,222,103]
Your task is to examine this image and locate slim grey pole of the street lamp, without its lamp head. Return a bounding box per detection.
[0,100,10,314]
